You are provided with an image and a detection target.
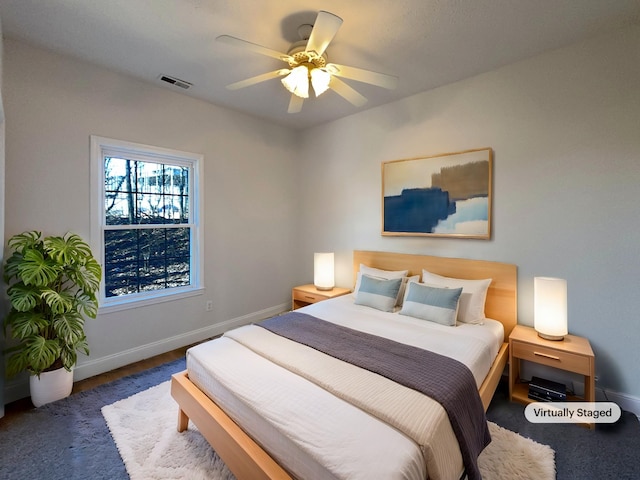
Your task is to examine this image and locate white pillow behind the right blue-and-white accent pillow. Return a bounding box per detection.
[422,270,492,324]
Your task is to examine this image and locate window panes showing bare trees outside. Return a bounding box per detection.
[104,156,192,298]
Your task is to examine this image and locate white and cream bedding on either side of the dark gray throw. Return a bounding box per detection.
[187,296,502,479]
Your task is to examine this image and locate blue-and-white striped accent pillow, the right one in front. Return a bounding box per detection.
[400,282,462,327]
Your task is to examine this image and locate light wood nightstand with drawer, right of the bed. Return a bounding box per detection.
[509,325,596,428]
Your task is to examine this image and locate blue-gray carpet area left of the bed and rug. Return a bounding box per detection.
[0,359,185,480]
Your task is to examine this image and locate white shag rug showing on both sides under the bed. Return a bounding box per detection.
[102,381,556,480]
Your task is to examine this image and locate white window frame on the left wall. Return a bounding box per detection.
[90,135,204,313]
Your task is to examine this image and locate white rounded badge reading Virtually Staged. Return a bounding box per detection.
[524,402,622,423]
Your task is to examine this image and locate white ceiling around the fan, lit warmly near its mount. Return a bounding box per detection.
[0,0,640,128]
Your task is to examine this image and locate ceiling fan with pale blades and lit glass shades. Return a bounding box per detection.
[216,11,398,113]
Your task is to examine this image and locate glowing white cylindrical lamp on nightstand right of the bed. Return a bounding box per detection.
[533,277,569,340]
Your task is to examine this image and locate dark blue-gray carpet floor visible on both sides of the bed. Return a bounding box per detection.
[0,359,640,480]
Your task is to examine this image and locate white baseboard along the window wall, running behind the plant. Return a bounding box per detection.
[4,303,291,403]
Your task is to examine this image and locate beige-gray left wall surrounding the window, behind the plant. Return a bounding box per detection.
[4,39,298,401]
